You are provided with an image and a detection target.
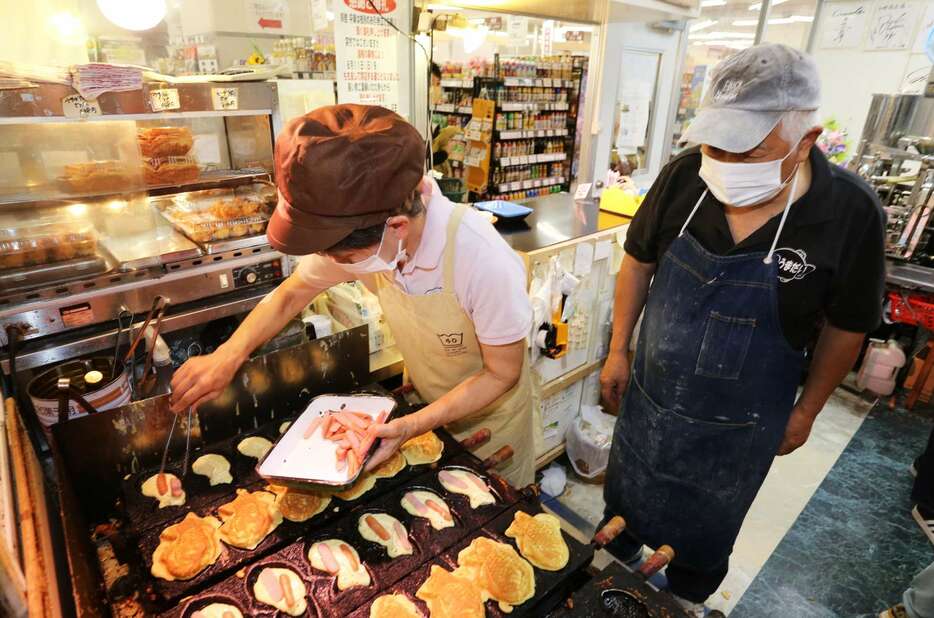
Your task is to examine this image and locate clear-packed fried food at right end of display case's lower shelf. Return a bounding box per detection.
[153,189,270,243]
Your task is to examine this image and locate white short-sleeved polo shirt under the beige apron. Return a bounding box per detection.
[296,183,532,345]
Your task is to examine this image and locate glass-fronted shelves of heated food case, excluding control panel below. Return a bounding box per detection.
[0,83,276,295]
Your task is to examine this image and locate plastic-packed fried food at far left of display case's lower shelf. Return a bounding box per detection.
[0,221,97,270]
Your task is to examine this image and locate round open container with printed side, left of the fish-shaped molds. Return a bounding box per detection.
[26,357,133,427]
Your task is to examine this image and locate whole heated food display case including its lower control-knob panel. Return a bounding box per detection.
[0,82,289,352]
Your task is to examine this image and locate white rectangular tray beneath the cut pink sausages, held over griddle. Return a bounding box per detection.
[256,395,396,487]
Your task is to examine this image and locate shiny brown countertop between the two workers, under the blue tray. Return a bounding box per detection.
[496,193,630,253]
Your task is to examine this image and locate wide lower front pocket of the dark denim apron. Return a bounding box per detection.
[617,380,756,504]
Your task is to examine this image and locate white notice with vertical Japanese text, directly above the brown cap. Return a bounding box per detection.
[334,0,402,112]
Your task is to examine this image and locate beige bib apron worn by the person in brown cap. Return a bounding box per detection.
[374,205,536,487]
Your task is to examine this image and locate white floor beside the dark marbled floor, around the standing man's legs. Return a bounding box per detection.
[559,389,872,613]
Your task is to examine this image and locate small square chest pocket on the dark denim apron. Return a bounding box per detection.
[694,311,756,380]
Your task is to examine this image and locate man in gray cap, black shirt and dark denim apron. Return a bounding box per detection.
[601,45,884,615]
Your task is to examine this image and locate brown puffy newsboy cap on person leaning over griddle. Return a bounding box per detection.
[266,104,425,255]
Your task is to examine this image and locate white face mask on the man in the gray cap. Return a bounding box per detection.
[700,144,798,207]
